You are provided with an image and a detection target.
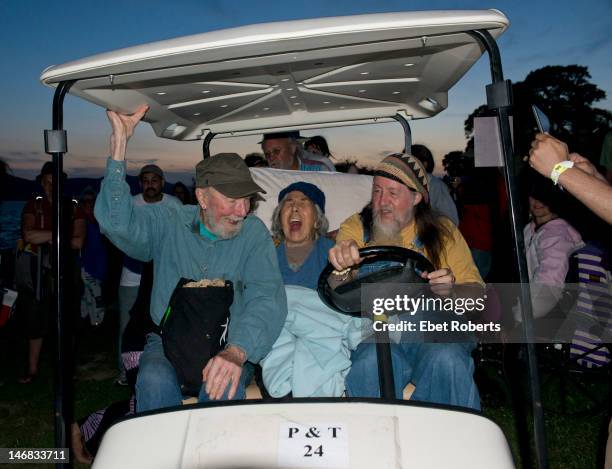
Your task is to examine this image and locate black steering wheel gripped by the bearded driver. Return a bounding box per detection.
[317,246,434,317]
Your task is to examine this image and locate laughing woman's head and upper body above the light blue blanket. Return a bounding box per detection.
[272,182,334,289]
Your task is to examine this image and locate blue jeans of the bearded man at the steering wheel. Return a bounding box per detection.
[346,342,480,410]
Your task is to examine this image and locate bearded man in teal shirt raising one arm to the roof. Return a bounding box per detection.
[95,106,287,412]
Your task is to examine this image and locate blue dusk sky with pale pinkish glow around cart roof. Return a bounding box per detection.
[0,0,612,183]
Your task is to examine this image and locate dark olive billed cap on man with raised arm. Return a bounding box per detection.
[196,153,266,199]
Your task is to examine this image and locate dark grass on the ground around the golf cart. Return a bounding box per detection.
[0,314,607,469]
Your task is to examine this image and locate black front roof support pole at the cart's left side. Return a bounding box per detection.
[45,81,74,468]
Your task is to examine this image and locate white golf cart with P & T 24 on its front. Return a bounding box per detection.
[41,10,546,468]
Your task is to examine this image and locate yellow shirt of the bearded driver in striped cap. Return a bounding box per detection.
[336,213,484,285]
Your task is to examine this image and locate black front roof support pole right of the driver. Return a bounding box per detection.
[470,30,548,469]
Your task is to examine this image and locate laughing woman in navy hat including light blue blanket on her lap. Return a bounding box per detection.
[261,182,362,398]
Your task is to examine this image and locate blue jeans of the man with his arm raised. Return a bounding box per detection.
[136,334,253,412]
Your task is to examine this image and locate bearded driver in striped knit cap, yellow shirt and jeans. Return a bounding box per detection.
[329,154,483,408]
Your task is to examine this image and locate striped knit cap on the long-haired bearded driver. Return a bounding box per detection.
[374,153,429,203]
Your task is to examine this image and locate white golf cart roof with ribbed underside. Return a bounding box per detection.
[41,10,508,140]
